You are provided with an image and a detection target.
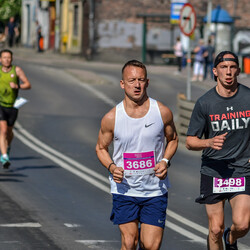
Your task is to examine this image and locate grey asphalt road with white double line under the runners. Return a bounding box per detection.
[0,49,250,250]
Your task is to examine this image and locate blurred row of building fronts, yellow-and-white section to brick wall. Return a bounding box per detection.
[22,0,250,61]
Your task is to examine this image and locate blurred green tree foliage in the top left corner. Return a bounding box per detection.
[0,0,22,22]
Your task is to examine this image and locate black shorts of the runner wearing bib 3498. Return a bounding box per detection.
[195,174,250,204]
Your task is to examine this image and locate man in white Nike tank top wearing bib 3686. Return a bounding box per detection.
[96,60,178,249]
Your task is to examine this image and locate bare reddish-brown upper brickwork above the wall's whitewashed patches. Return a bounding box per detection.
[96,0,250,29]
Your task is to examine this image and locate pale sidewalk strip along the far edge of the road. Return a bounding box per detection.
[12,47,250,89]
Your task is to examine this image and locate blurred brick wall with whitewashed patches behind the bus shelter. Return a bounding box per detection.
[95,0,250,60]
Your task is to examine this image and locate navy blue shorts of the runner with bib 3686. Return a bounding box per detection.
[110,193,168,228]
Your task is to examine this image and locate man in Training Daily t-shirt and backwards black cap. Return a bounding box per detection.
[186,51,250,250]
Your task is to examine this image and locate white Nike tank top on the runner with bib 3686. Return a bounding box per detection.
[109,98,168,197]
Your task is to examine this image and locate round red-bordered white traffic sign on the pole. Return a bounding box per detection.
[179,3,196,36]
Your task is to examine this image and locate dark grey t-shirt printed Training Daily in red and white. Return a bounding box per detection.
[187,84,250,178]
